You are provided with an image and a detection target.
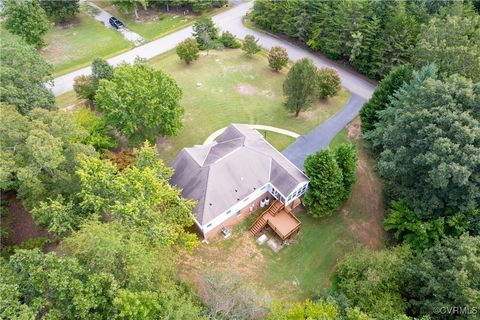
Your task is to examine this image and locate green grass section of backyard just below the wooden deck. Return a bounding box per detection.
[261,211,360,300]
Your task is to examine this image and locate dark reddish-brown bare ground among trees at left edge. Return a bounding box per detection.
[2,192,49,246]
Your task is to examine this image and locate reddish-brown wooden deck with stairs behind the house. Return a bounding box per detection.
[250,201,301,240]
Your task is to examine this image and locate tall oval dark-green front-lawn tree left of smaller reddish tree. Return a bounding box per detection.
[283,58,317,117]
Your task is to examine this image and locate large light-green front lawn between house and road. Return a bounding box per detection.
[149,50,350,162]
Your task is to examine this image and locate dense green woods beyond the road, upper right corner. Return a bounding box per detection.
[250,0,479,79]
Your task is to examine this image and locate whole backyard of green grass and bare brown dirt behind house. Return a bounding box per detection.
[180,120,384,301]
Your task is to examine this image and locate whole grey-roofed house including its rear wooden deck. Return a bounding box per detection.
[170,124,308,239]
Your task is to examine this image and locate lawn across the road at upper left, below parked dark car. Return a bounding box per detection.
[41,13,132,76]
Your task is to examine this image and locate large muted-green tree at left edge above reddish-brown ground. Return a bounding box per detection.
[0,107,96,210]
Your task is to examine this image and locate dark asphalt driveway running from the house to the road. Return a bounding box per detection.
[282,94,365,170]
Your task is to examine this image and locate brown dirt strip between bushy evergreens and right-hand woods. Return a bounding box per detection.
[341,118,385,249]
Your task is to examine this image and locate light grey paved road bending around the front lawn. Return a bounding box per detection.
[52,1,375,99]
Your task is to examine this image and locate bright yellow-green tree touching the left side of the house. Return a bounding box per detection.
[77,145,196,248]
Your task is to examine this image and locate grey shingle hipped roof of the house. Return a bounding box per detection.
[170,124,307,225]
